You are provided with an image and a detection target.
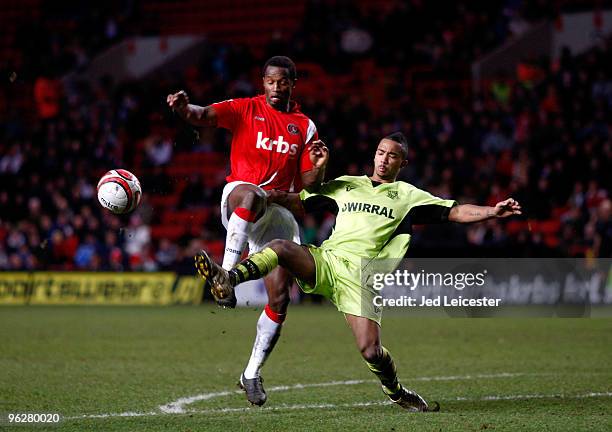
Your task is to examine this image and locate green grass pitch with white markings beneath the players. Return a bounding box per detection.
[0,306,612,431]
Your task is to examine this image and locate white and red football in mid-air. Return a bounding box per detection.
[98,169,142,214]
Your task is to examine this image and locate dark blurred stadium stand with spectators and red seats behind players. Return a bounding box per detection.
[0,0,612,273]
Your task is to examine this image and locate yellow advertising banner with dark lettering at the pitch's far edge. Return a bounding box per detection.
[0,272,203,305]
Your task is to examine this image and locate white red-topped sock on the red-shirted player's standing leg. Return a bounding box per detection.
[244,305,286,379]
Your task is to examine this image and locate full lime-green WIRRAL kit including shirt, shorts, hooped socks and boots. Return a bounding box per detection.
[219,176,456,411]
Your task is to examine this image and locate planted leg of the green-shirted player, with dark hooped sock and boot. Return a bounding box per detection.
[345,314,440,411]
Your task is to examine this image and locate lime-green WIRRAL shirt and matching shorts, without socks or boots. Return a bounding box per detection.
[297,176,456,324]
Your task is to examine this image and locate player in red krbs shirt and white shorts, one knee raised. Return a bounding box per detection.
[167,56,329,405]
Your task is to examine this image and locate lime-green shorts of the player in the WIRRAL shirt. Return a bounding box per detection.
[296,245,382,325]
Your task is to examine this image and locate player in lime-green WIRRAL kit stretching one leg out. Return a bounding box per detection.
[195,132,521,411]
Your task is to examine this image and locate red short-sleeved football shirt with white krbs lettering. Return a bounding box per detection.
[212,95,318,191]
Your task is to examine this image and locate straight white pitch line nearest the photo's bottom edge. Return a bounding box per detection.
[64,392,612,420]
